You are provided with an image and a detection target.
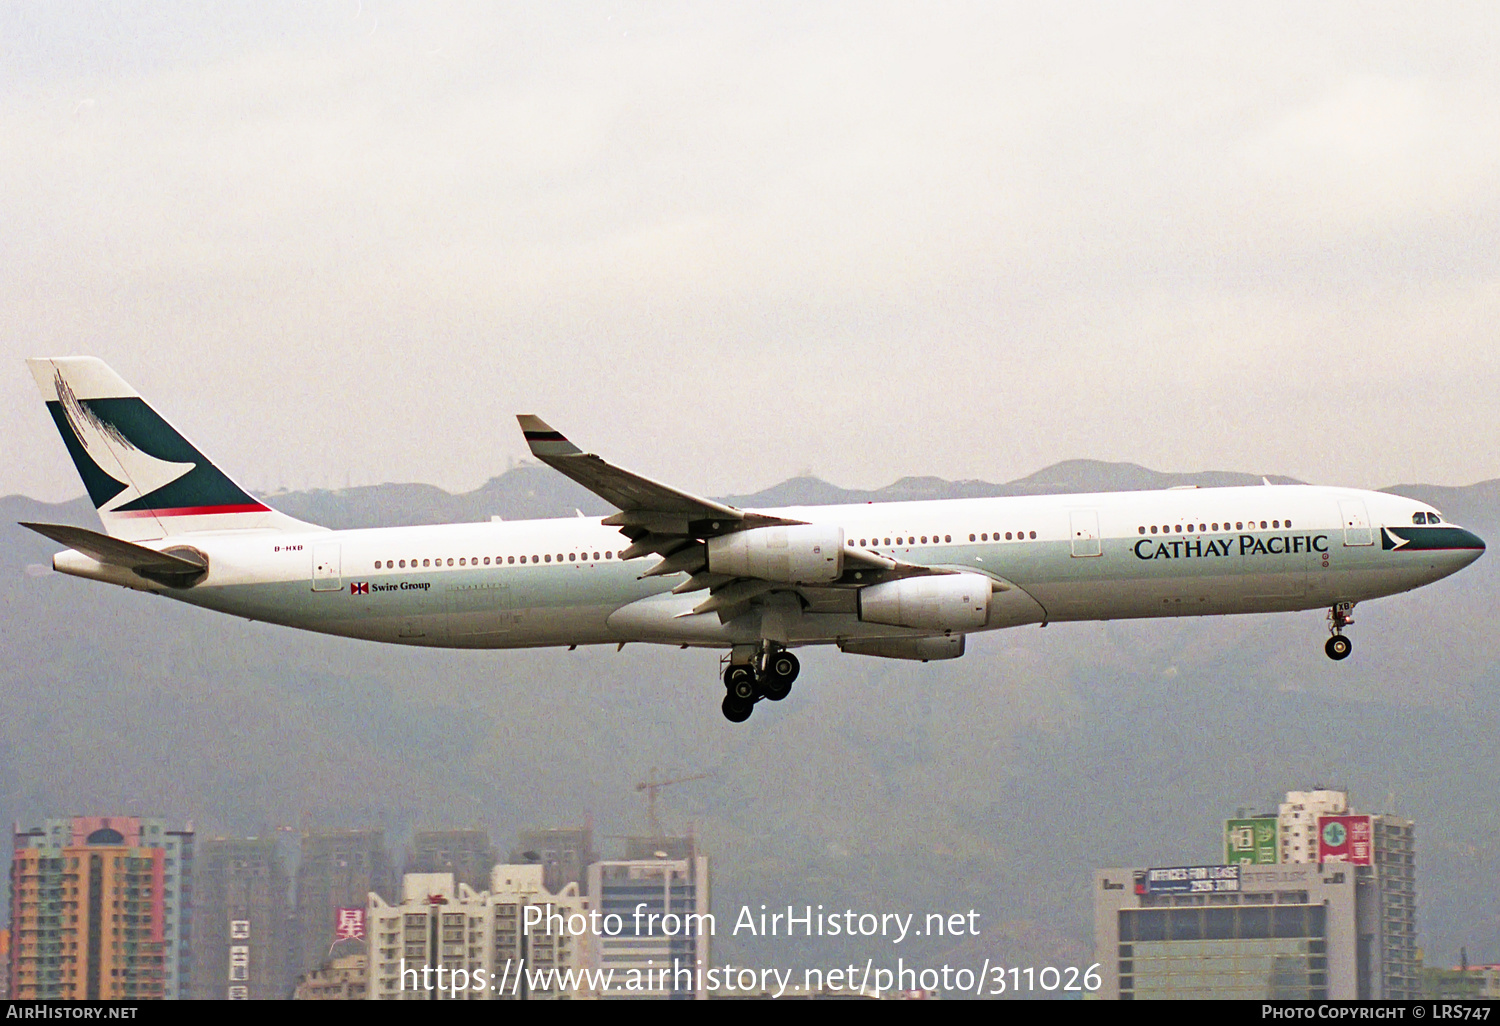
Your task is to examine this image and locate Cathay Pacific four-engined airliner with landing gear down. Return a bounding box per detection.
[26,357,1485,722]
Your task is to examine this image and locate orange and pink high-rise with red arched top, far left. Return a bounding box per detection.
[9,816,194,1001]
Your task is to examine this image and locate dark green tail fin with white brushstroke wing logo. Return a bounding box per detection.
[26,357,315,542]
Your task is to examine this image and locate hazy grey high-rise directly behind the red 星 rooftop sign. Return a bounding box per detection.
[296,830,396,972]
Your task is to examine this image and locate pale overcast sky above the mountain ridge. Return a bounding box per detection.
[0,0,1500,500]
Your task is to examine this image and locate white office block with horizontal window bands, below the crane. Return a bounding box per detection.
[588,839,711,999]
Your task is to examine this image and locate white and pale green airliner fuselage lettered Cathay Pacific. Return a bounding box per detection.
[56,486,1484,648]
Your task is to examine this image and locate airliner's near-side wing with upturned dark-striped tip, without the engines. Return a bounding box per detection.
[516,414,953,621]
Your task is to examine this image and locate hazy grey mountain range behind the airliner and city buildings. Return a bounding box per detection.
[0,461,1500,968]
